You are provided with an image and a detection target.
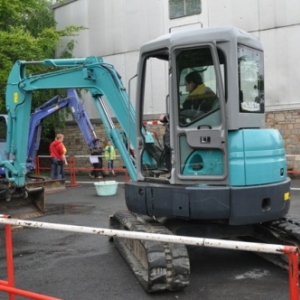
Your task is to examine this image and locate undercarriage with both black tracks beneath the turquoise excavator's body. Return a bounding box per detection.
[110,211,300,292]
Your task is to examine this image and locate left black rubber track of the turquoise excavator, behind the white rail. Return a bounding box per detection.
[110,211,190,292]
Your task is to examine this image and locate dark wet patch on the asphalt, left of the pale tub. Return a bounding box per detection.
[45,203,95,216]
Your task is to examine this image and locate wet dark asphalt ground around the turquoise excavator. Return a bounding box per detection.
[0,176,300,300]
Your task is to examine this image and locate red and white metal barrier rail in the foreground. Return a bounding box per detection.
[0,215,299,300]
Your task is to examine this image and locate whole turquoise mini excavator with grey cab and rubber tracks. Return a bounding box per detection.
[0,27,300,292]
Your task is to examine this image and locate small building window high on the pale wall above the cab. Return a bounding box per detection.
[169,0,201,19]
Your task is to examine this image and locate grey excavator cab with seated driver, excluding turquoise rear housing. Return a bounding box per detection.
[137,28,264,185]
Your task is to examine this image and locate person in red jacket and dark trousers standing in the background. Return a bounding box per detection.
[49,133,68,179]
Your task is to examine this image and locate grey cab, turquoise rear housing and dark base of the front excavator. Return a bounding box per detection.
[125,27,290,224]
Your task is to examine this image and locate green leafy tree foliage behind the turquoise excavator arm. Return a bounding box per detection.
[0,0,85,142]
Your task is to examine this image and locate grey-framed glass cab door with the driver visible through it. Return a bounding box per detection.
[170,44,228,183]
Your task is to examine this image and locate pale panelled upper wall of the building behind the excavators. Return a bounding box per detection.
[55,0,300,118]
